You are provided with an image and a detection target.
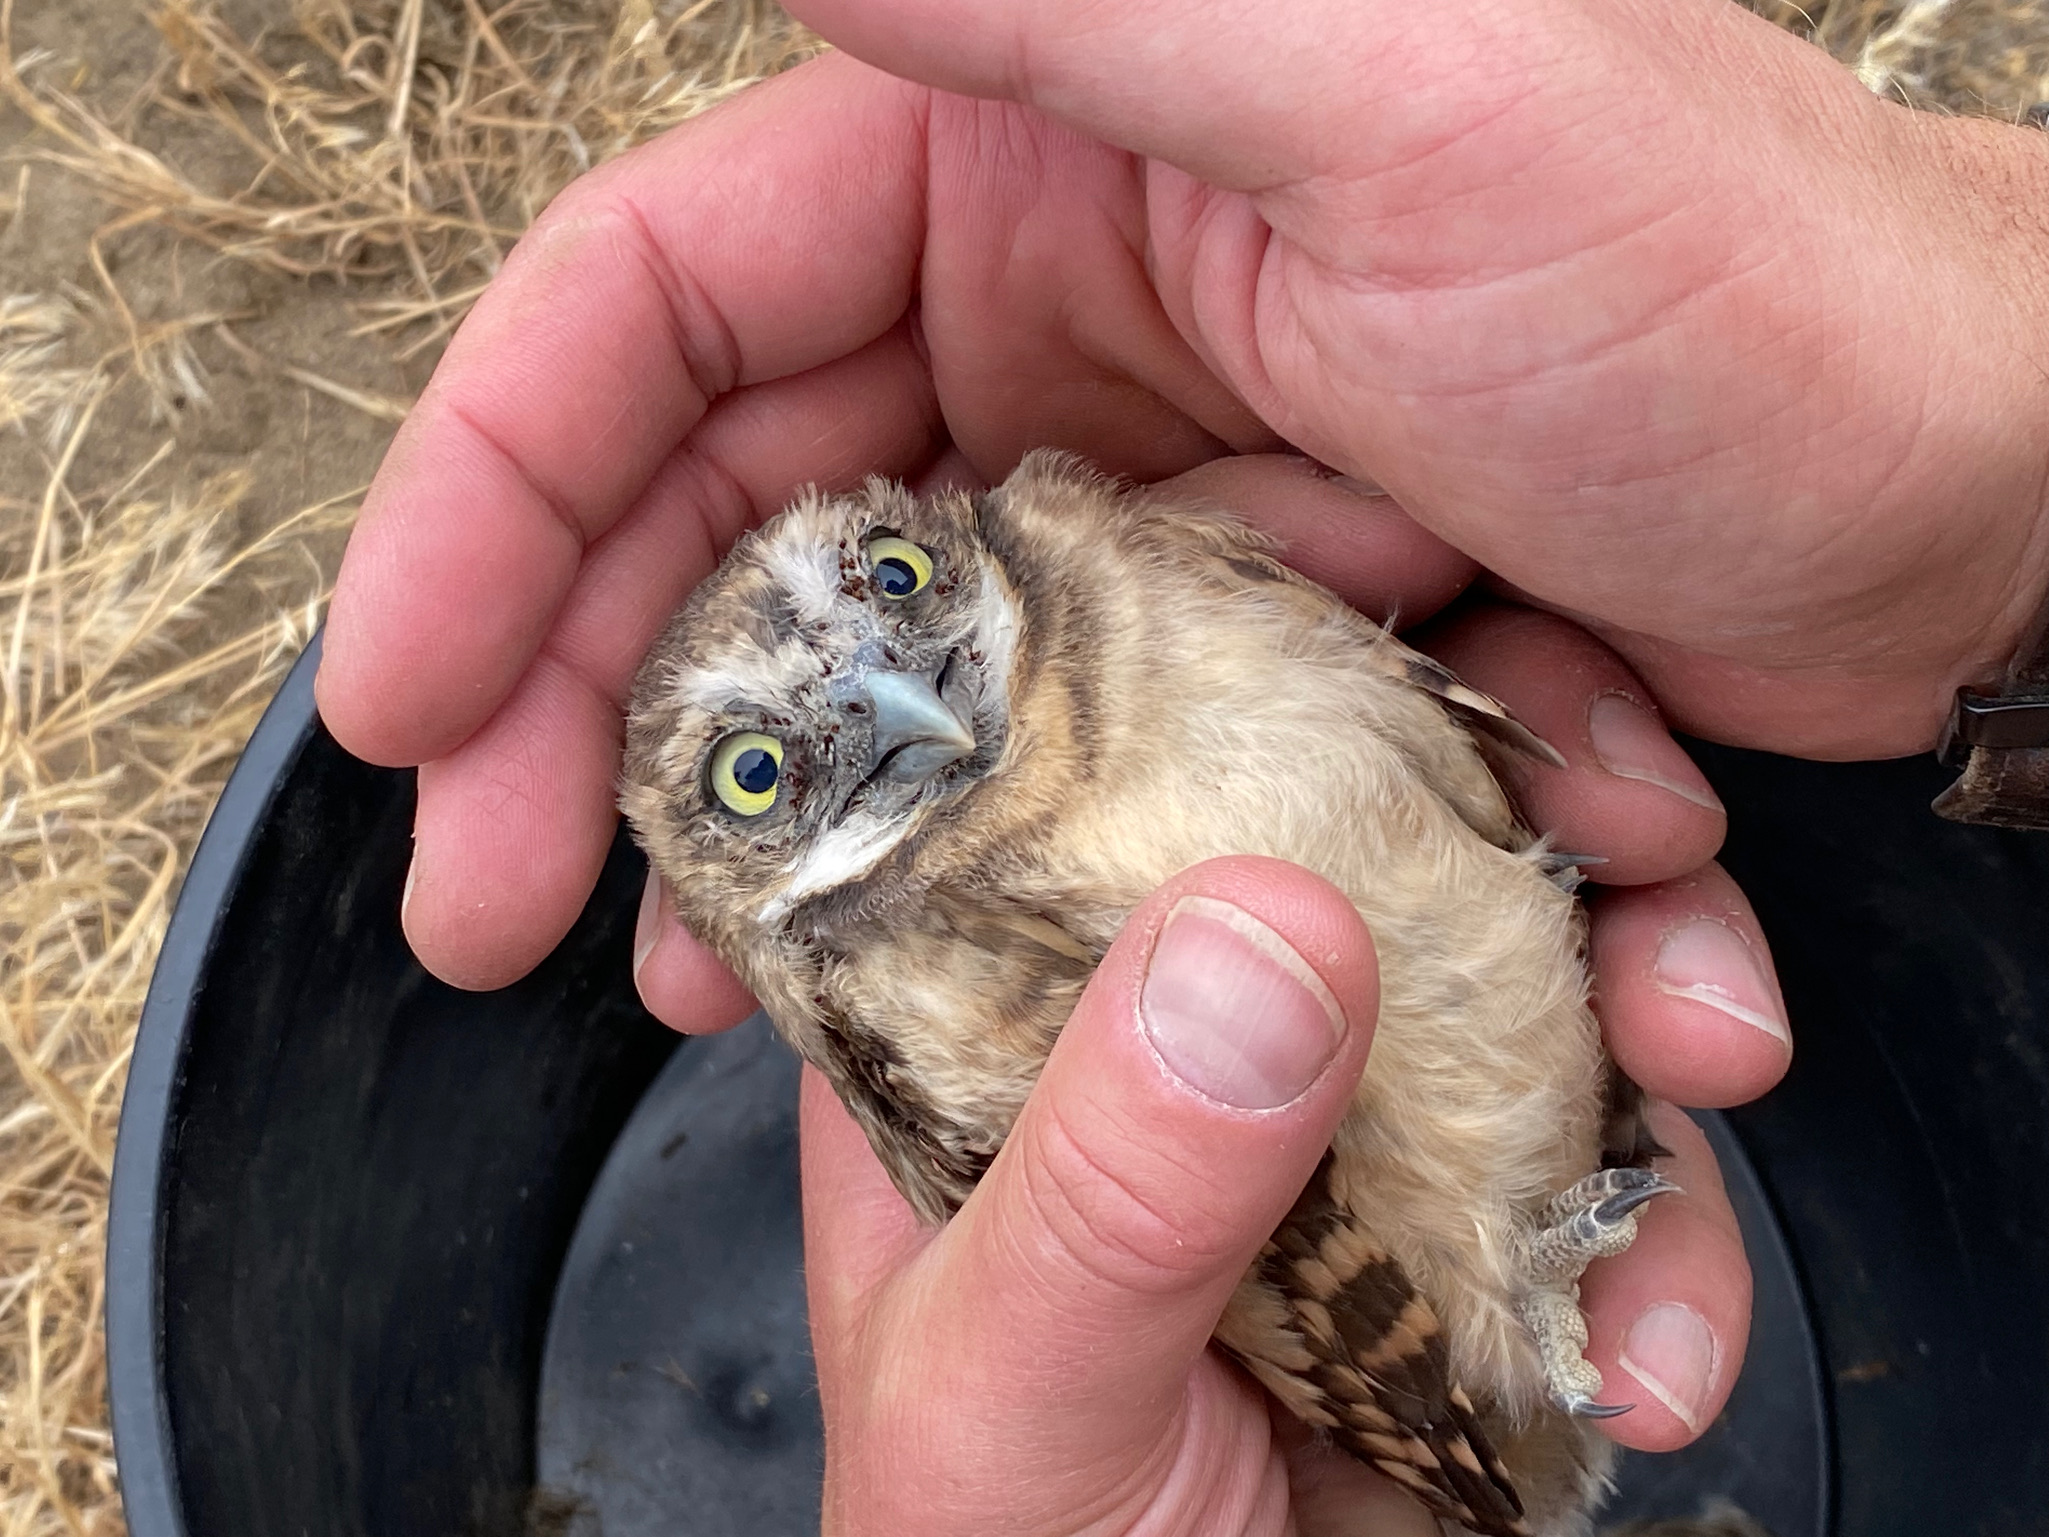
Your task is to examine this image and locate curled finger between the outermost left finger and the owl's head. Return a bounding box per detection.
[404,326,943,988]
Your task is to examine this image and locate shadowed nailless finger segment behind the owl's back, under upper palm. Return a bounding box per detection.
[1160,453,1479,623]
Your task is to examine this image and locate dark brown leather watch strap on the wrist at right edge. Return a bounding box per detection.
[1934,605,2049,830]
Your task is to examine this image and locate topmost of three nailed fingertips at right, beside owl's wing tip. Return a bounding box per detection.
[1410,603,1729,885]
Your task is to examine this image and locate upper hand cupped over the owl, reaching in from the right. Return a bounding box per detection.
[320,0,2045,1000]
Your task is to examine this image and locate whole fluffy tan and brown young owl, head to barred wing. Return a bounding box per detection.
[623,453,1647,1537]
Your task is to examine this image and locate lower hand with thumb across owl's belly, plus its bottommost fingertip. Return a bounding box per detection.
[803,859,1748,1537]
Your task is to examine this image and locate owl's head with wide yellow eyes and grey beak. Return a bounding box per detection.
[621,480,1020,963]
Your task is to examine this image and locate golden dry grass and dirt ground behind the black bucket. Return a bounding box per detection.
[0,0,2043,1537]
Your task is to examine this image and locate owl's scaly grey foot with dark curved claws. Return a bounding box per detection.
[1520,1168,1678,1420]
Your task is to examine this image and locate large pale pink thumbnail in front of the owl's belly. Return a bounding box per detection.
[1139,898,1344,1111]
